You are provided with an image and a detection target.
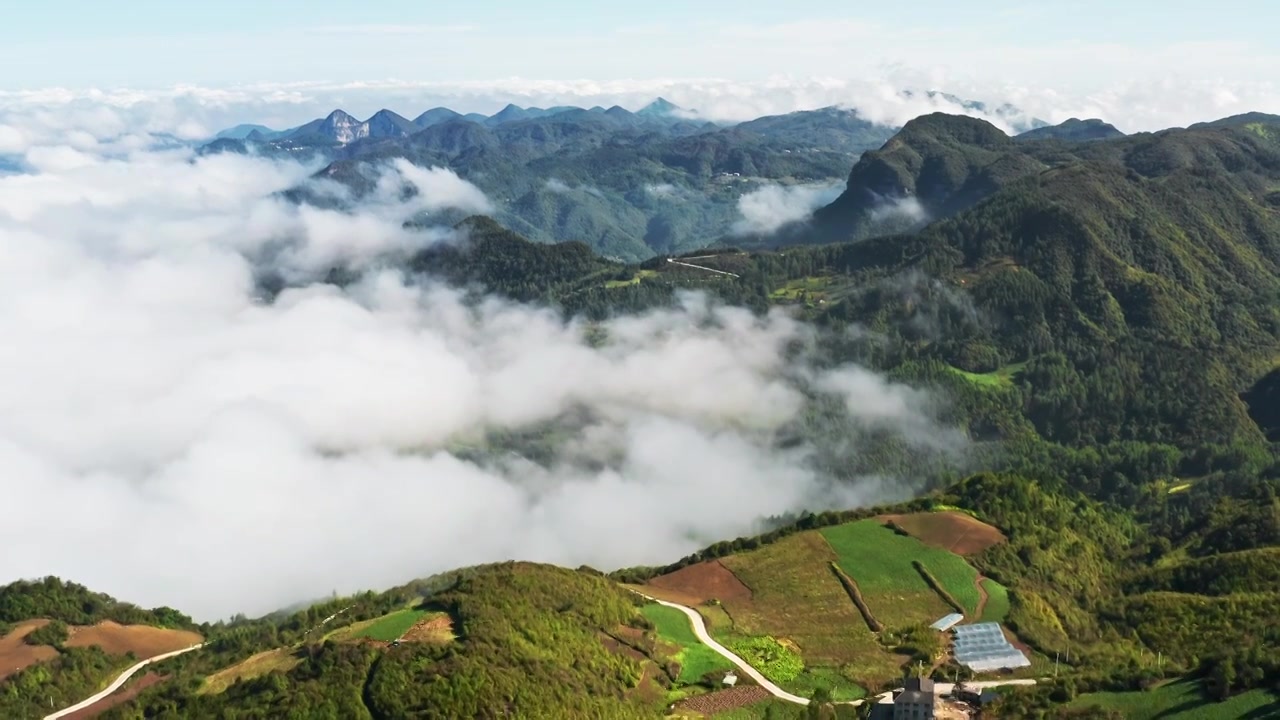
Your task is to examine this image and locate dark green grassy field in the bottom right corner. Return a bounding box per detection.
[1071,680,1280,720]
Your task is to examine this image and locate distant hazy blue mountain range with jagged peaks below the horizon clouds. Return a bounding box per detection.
[202,94,1070,261]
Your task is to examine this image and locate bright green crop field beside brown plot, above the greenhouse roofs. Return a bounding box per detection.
[819,520,979,626]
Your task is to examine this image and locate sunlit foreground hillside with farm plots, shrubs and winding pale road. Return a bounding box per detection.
[0,468,1280,719]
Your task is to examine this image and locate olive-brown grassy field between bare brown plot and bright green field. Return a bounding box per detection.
[721,532,901,685]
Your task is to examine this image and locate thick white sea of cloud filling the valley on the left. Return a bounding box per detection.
[0,130,951,619]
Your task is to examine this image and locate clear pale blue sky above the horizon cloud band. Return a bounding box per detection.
[0,0,1280,90]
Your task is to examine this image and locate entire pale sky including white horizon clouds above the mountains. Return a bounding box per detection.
[0,0,1280,131]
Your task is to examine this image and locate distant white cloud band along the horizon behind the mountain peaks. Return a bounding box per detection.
[0,74,1280,156]
